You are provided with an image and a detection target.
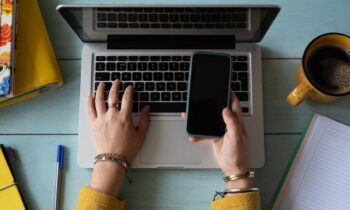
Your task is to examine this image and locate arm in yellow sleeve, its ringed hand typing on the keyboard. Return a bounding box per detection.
[76,81,149,210]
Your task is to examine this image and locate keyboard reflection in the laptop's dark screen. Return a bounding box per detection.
[95,7,249,30]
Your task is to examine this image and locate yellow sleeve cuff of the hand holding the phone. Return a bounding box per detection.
[211,192,260,210]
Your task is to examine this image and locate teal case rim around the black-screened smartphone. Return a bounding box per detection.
[186,51,232,138]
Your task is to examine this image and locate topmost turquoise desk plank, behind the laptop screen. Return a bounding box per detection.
[39,0,350,59]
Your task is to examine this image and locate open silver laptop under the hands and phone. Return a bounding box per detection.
[57,4,280,169]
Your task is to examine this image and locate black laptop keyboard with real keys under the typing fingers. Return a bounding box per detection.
[94,55,249,113]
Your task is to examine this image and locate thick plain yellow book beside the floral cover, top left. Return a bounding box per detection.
[0,0,63,108]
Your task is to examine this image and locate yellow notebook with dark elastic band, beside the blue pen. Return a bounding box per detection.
[0,145,26,210]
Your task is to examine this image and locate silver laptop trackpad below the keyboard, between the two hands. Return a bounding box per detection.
[141,120,201,165]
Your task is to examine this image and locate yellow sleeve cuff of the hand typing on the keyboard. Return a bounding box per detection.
[76,187,125,210]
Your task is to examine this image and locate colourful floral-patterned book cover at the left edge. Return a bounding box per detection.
[0,0,16,97]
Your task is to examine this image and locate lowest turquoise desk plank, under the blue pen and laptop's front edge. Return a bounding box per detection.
[0,135,300,210]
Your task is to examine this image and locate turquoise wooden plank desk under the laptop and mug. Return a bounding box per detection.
[0,0,350,210]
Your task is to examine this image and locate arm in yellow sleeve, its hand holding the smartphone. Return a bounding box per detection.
[189,93,260,210]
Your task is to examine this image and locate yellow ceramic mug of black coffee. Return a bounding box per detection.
[287,33,350,106]
